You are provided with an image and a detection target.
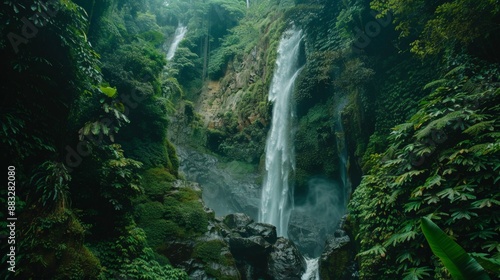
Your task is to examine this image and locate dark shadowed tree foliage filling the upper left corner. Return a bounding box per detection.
[0,1,102,164]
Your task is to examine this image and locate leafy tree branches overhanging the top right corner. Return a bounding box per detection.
[371,0,500,56]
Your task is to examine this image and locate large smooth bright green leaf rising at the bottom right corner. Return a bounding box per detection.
[421,217,490,280]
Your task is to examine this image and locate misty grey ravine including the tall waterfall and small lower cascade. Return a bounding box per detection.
[172,30,350,280]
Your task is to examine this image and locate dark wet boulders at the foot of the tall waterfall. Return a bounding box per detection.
[222,214,306,280]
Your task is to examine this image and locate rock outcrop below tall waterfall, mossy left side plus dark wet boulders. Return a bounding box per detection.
[160,213,306,280]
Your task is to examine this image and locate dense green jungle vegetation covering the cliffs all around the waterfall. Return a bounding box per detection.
[0,0,500,279]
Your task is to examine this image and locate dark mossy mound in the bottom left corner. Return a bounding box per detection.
[16,211,102,279]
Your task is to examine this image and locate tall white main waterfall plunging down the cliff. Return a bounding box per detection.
[259,30,302,237]
